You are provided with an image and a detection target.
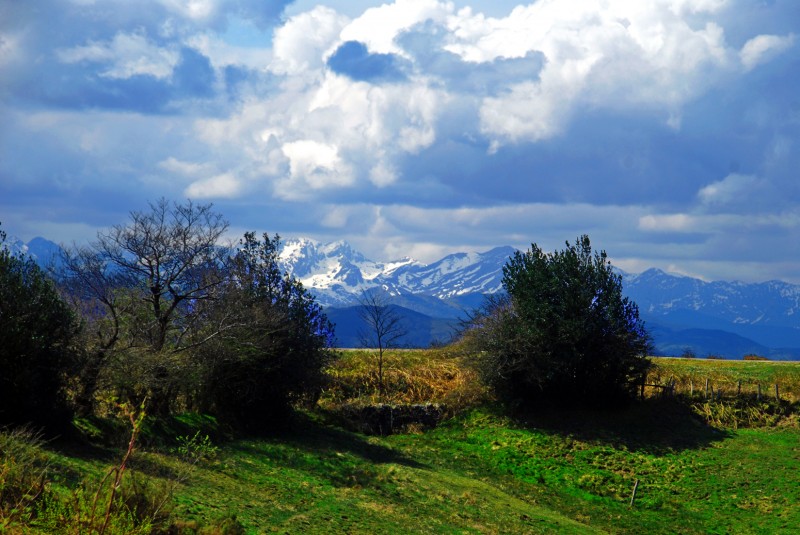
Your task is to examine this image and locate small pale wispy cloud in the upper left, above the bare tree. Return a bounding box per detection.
[56,32,180,78]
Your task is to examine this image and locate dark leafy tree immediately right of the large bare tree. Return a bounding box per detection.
[204,232,334,425]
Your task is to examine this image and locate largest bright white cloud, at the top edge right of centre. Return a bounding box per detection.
[446,0,731,141]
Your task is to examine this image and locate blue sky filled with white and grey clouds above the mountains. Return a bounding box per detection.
[0,0,800,284]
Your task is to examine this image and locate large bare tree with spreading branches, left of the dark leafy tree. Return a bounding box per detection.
[64,199,229,414]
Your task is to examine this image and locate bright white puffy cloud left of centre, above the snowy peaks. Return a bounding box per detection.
[197,65,446,199]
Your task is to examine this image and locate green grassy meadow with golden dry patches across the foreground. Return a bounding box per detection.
[0,348,800,534]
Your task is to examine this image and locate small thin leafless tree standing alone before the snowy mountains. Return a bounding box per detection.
[358,289,408,395]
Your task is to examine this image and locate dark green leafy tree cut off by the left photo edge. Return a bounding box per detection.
[0,224,80,429]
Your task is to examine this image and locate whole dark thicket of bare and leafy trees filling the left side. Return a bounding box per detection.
[0,199,334,432]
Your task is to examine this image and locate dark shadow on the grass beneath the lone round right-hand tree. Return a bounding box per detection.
[517,398,731,455]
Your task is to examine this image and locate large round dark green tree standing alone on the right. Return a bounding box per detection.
[466,235,650,408]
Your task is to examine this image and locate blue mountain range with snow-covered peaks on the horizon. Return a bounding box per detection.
[5,238,800,360]
